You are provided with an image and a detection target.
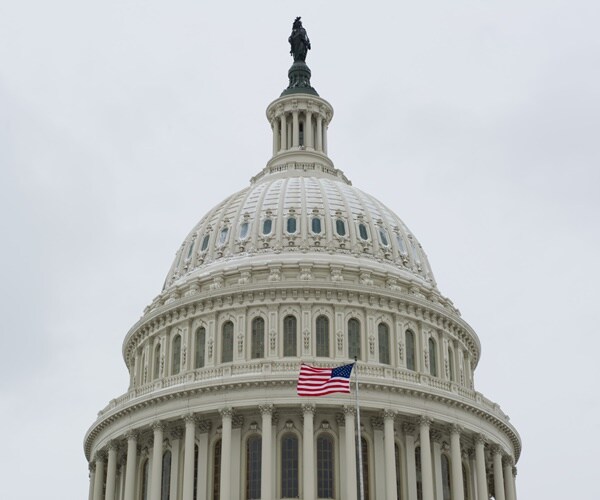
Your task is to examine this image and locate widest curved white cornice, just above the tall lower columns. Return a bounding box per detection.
[84,368,521,462]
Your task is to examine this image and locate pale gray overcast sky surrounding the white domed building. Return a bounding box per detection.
[0,0,600,500]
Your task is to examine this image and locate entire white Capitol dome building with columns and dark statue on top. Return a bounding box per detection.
[84,18,521,500]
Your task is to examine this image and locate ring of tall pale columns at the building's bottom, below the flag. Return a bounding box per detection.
[89,403,516,500]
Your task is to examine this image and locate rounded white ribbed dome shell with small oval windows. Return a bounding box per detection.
[165,166,434,288]
